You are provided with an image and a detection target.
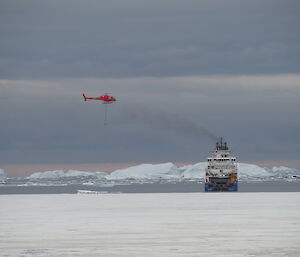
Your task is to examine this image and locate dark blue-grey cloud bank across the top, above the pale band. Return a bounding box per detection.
[0,0,300,78]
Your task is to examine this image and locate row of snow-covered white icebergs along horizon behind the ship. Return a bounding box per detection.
[28,162,300,181]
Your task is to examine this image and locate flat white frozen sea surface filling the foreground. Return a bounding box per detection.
[0,192,300,257]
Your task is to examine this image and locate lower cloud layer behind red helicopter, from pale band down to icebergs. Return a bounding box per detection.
[0,74,300,163]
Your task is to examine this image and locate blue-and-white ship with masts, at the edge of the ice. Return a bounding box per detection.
[204,138,238,192]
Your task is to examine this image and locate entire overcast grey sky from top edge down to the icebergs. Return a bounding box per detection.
[0,0,300,173]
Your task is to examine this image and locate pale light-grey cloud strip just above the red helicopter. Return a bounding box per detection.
[0,74,300,93]
